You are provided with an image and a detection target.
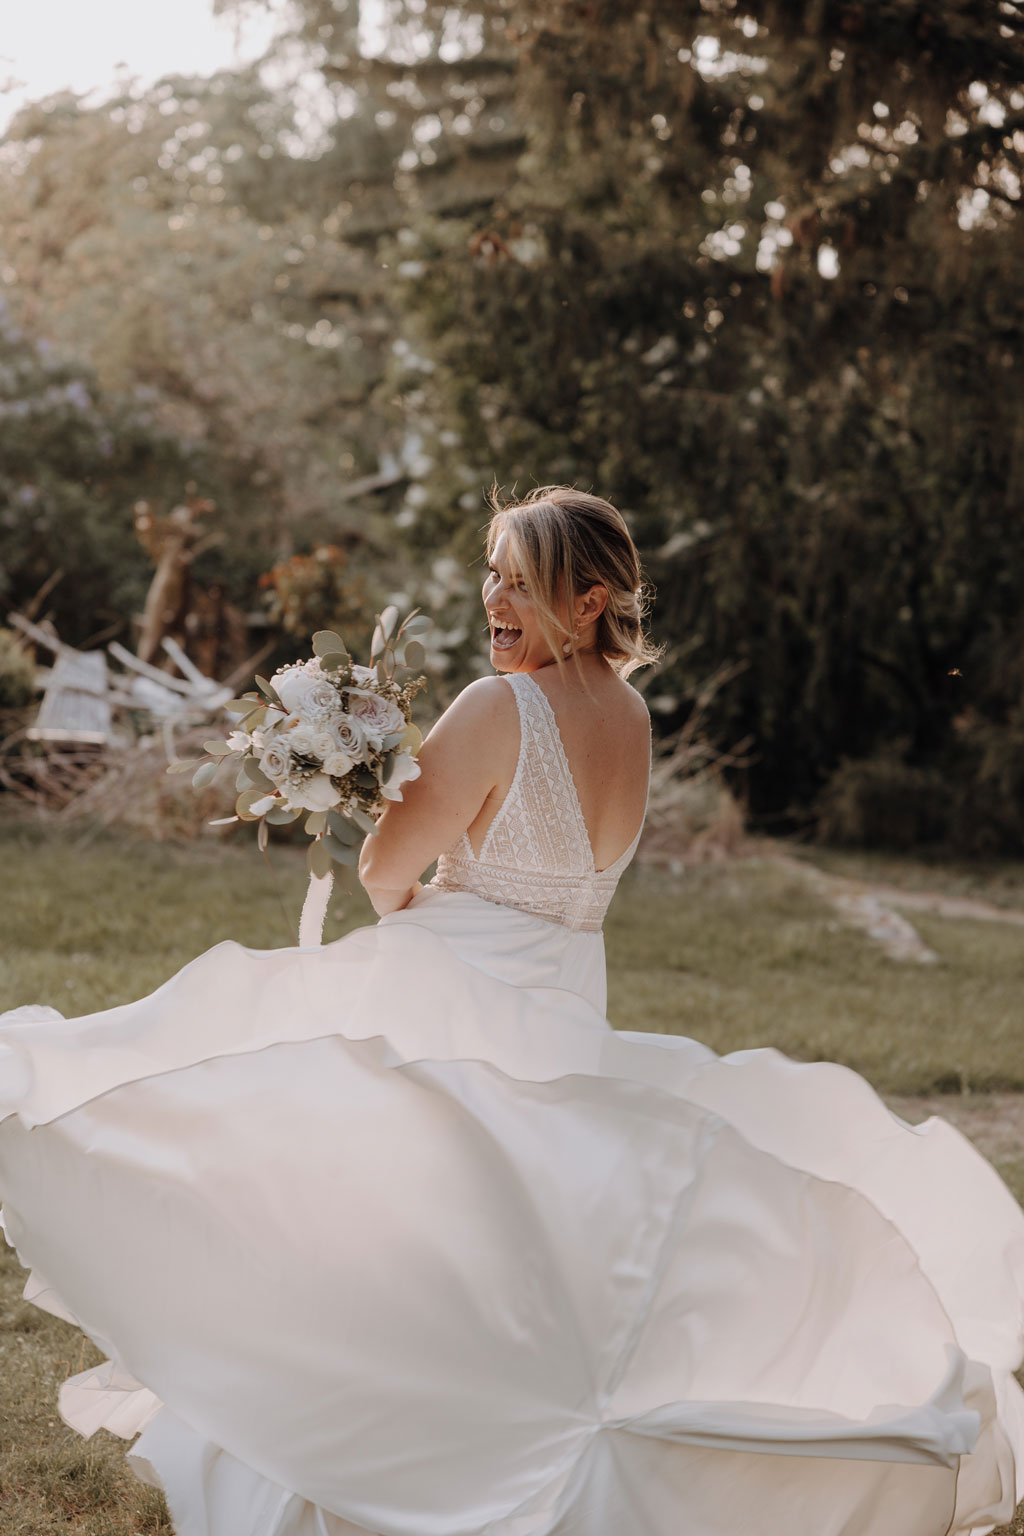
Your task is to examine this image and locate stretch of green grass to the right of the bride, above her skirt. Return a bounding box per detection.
[606,860,1024,1094]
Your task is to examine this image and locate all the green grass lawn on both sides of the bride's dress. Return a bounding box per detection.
[0,822,1024,1536]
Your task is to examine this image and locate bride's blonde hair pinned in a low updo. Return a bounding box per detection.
[487,485,662,677]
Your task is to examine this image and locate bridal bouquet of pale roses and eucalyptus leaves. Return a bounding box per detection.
[174,607,431,879]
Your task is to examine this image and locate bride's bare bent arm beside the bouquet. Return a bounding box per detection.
[359,677,519,917]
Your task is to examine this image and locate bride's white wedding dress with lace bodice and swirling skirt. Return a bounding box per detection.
[0,674,1024,1536]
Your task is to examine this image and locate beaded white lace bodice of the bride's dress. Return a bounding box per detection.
[431,673,640,932]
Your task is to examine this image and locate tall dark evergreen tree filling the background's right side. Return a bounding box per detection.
[330,0,1024,849]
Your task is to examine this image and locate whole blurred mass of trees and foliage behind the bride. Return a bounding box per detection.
[0,0,1024,854]
